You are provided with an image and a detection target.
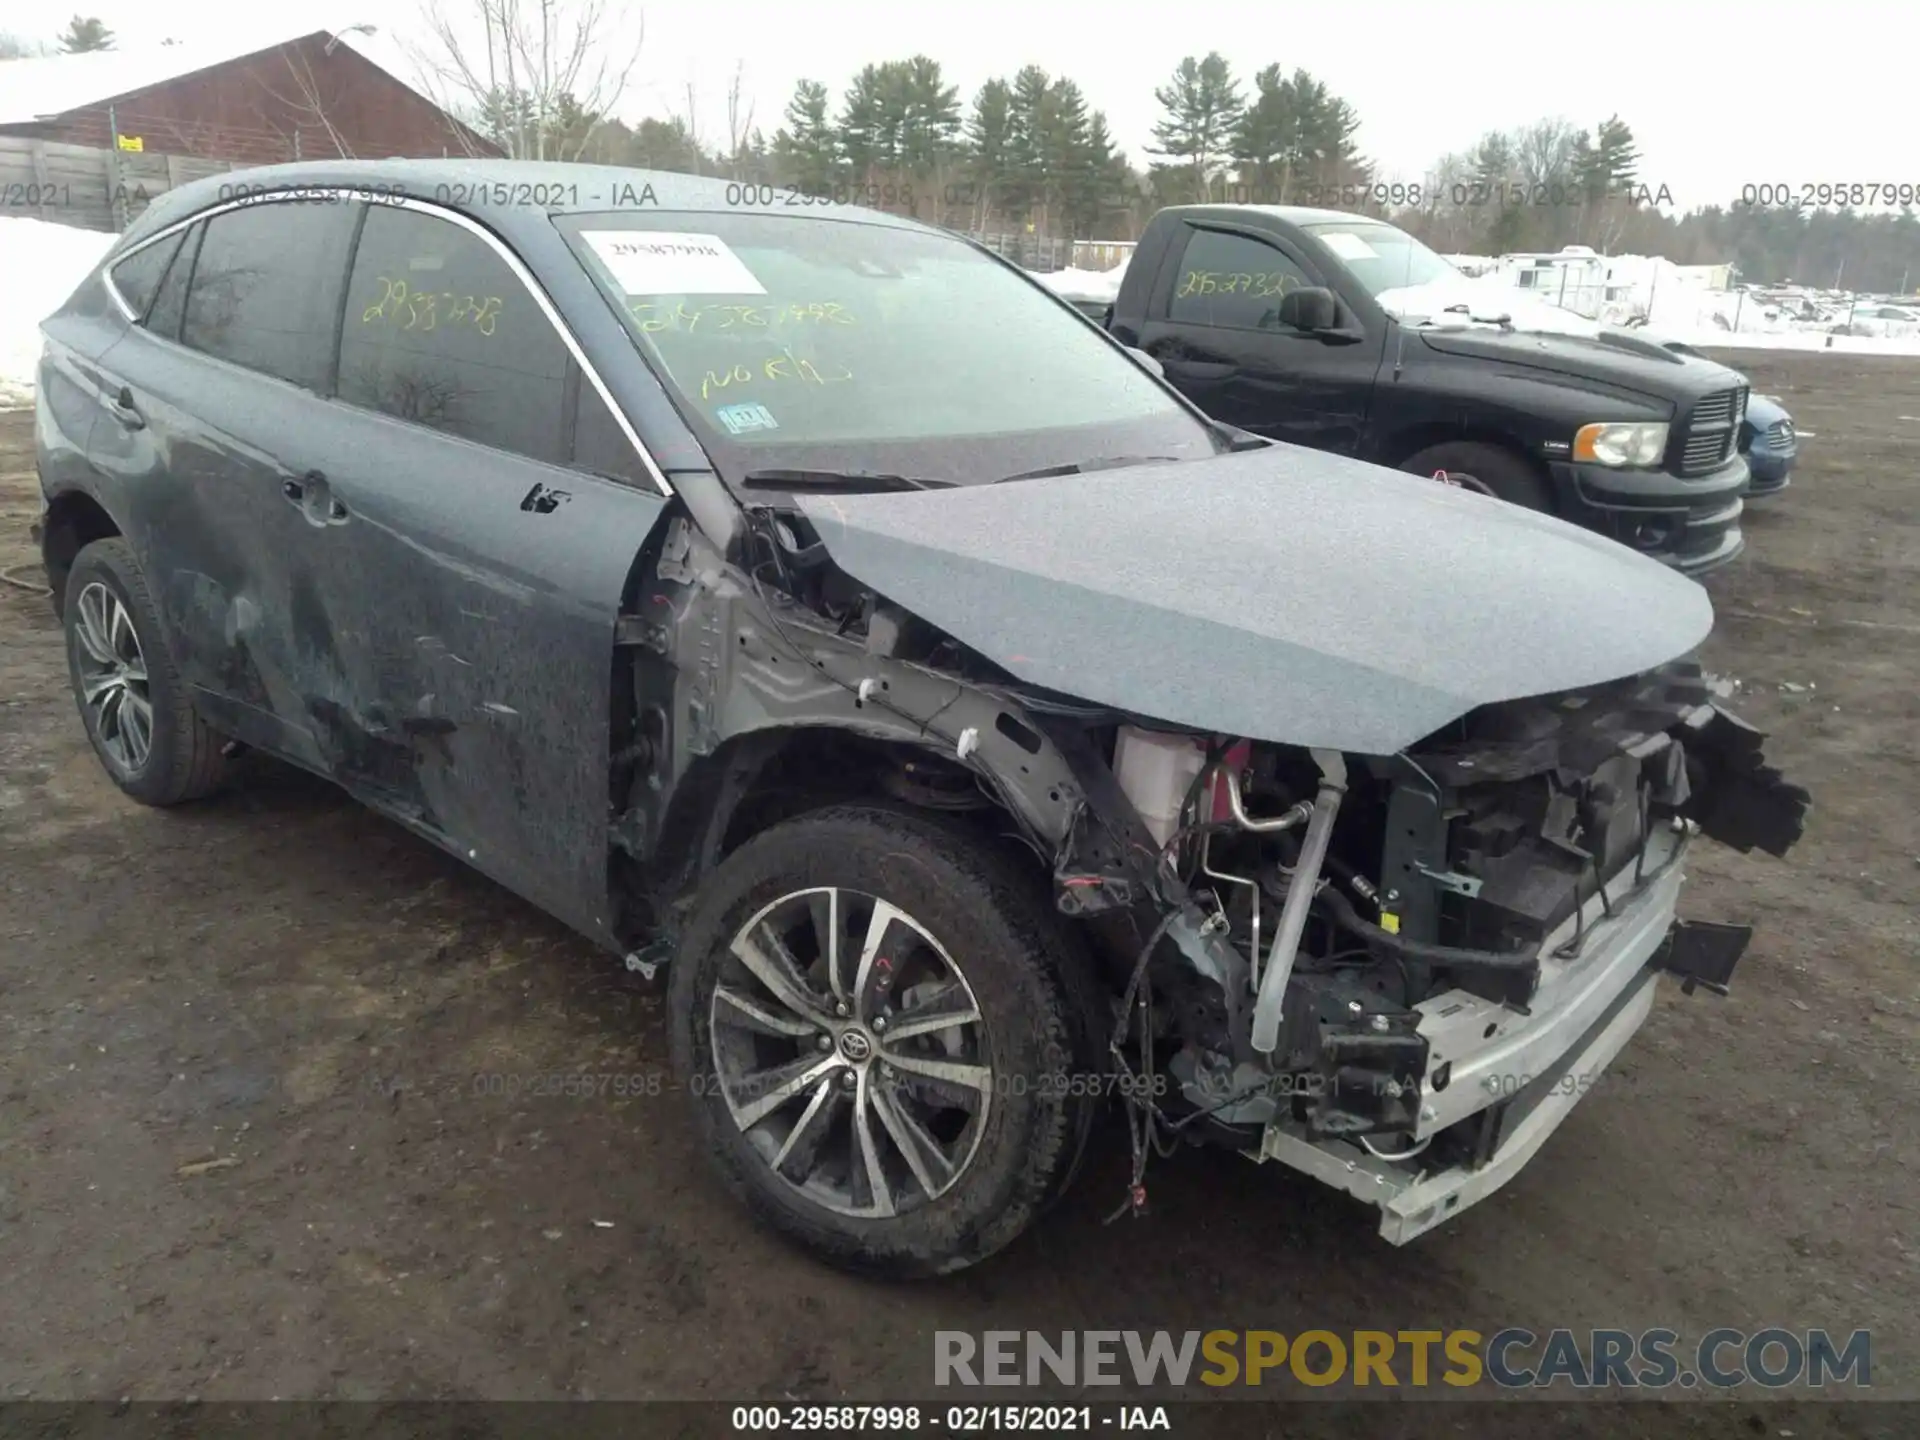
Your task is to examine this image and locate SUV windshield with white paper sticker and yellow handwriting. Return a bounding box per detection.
[559,211,1217,484]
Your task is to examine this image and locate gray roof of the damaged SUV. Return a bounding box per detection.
[129,156,935,247]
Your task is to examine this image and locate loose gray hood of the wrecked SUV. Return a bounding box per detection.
[799,445,1713,755]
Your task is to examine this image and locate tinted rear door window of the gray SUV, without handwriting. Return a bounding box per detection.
[180,202,359,394]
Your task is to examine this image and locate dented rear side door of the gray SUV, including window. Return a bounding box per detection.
[88,200,361,772]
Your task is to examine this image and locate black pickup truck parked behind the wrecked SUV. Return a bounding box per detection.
[1056,205,1747,574]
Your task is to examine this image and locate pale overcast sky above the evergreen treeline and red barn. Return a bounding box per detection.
[0,0,1920,207]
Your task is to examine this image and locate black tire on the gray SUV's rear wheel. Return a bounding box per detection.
[61,536,227,804]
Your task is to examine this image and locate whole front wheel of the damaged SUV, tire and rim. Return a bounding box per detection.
[672,806,1098,1277]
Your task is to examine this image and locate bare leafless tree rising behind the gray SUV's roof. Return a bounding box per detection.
[407,0,645,159]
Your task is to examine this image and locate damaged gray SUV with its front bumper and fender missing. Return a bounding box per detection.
[38,161,1807,1275]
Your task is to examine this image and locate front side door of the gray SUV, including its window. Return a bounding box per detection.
[311,202,664,948]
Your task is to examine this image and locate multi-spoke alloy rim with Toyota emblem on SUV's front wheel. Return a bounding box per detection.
[707,887,993,1219]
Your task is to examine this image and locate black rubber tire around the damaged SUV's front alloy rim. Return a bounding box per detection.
[670,806,1106,1279]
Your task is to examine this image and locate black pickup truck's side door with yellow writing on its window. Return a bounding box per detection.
[1140,225,1380,455]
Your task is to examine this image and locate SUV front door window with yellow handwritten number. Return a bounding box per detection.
[340,205,572,465]
